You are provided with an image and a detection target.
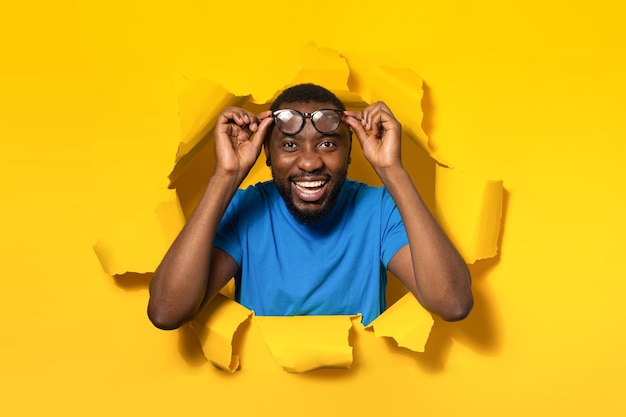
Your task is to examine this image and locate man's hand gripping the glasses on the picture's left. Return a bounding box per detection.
[215,107,273,181]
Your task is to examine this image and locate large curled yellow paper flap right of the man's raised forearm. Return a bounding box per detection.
[435,166,504,264]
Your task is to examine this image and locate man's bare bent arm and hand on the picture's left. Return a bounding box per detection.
[148,107,272,329]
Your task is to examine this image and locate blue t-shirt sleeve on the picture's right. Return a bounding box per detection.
[381,187,409,268]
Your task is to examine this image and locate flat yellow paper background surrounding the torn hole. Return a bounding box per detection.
[0,0,626,416]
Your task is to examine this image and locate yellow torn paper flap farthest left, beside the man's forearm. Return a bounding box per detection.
[93,190,185,275]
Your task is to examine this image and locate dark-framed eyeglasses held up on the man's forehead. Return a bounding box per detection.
[272,109,343,135]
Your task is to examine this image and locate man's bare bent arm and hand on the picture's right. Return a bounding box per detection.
[345,102,474,321]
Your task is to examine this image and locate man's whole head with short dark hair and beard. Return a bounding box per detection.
[265,84,352,224]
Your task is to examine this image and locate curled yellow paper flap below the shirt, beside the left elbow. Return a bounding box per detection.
[190,293,254,373]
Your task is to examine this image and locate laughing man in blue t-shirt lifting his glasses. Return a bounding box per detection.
[148,84,473,329]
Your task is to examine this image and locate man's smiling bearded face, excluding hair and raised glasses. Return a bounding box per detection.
[265,102,351,224]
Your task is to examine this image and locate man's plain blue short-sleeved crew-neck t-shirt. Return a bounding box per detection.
[214,180,408,325]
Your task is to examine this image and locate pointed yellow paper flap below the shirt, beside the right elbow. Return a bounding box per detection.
[366,293,434,352]
